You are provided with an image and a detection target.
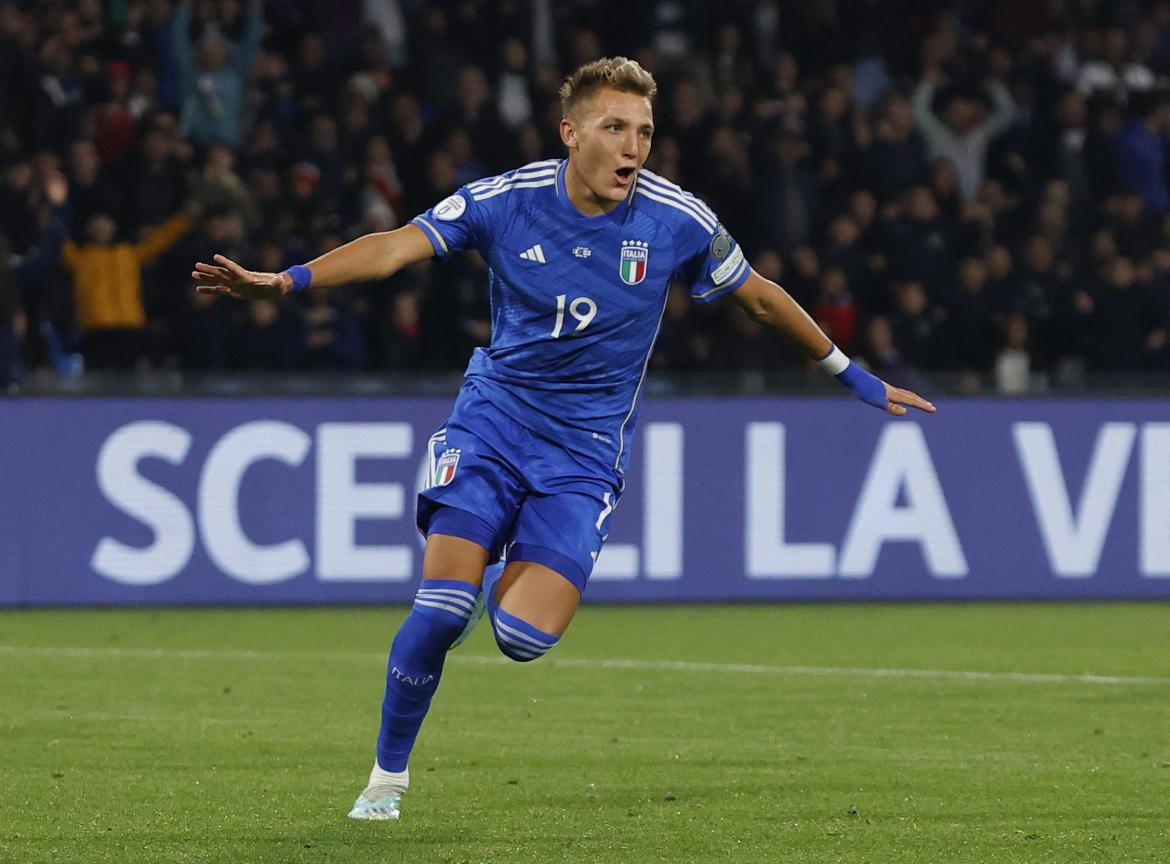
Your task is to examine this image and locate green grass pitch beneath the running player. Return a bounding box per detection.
[0,604,1170,864]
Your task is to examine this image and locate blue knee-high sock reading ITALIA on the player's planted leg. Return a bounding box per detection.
[378,580,480,772]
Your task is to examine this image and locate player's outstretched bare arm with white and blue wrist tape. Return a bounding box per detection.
[731,270,935,417]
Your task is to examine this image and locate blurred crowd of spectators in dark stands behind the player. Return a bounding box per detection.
[0,0,1170,392]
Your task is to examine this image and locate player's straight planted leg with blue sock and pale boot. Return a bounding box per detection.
[350,529,490,820]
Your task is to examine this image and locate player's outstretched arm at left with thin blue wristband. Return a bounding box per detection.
[191,225,434,300]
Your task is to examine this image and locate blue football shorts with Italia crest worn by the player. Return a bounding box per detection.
[418,380,619,591]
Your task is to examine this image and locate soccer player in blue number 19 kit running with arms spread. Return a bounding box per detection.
[192,57,934,820]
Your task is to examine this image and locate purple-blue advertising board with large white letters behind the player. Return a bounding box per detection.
[0,398,1170,605]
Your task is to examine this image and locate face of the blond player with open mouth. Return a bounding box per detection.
[560,88,654,201]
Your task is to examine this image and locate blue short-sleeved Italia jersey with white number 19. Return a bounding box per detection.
[412,159,749,482]
